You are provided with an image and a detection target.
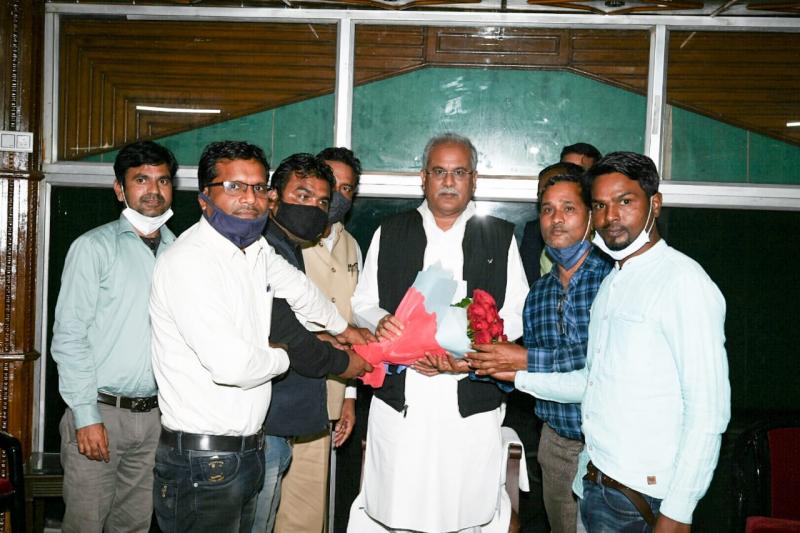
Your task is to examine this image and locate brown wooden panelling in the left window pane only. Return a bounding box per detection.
[59,19,336,159]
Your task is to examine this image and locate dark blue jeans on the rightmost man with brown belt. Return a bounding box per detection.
[580,479,661,533]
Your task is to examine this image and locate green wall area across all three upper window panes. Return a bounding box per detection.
[81,68,800,184]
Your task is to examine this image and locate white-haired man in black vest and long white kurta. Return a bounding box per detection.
[348,133,527,533]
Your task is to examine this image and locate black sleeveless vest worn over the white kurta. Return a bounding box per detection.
[375,209,514,417]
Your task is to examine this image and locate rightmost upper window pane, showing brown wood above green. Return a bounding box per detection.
[667,32,800,184]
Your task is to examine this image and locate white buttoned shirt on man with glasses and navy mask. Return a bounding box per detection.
[150,218,347,435]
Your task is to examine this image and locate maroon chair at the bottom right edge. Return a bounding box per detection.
[735,418,800,533]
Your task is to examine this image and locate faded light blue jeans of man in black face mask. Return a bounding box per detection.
[252,435,292,533]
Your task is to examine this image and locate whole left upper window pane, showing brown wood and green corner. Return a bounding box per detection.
[59,17,336,165]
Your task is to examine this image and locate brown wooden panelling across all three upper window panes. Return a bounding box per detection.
[59,19,800,159]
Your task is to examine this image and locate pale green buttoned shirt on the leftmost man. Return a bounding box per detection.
[50,215,175,428]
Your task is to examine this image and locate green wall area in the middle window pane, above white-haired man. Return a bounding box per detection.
[353,68,646,172]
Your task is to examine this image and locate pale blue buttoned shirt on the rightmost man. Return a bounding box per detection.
[515,240,730,523]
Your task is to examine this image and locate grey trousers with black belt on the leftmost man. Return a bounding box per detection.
[59,404,161,533]
